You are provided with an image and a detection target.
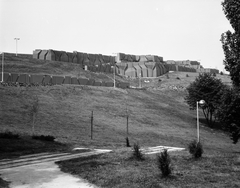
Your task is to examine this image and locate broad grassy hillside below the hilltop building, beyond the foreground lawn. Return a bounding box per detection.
[0,54,237,151]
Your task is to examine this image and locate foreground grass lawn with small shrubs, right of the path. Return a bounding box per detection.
[58,149,240,188]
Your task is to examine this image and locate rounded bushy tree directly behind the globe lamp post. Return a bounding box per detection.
[185,73,226,126]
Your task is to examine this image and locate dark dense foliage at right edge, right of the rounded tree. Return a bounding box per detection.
[217,88,240,144]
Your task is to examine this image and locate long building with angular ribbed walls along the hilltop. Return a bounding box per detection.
[33,49,219,78]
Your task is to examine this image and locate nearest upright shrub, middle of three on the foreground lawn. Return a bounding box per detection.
[157,149,172,177]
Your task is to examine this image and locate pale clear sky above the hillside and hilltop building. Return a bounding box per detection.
[0,0,232,72]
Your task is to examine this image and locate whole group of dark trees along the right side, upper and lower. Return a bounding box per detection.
[185,0,240,144]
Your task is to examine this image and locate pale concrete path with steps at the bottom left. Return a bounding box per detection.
[0,150,110,188]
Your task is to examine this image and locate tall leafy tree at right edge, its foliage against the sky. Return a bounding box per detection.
[221,0,240,86]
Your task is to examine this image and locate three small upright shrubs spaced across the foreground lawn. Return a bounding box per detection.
[132,140,203,177]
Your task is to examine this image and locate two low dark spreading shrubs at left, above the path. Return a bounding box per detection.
[0,131,55,142]
